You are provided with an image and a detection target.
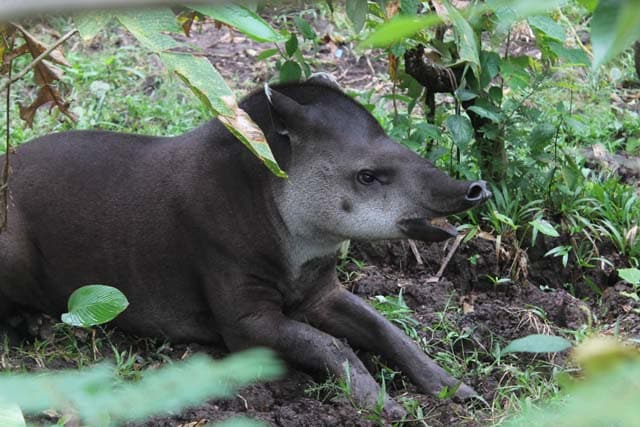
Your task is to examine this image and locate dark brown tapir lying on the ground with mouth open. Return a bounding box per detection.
[0,76,491,418]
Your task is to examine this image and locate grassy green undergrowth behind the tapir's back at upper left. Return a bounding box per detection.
[0,22,210,152]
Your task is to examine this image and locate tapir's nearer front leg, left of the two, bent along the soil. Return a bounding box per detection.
[212,288,406,419]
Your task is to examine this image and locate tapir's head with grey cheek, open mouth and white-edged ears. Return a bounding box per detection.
[267,77,491,241]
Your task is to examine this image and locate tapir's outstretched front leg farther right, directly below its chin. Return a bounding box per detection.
[298,286,477,399]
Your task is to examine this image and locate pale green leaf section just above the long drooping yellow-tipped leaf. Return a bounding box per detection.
[115,8,181,53]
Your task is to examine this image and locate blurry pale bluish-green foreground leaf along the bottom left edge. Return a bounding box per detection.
[0,349,283,427]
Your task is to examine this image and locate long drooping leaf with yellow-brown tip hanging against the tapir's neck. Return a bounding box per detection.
[160,53,287,177]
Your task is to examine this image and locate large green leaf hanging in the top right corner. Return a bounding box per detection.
[591,0,640,69]
